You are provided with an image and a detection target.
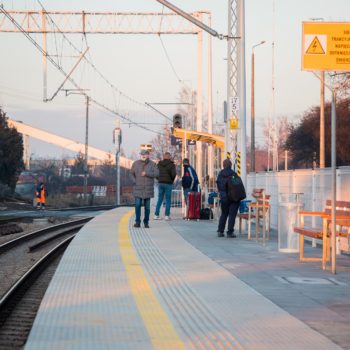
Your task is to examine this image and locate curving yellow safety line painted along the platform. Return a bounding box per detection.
[118,211,185,349]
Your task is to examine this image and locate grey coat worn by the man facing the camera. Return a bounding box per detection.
[131,159,159,199]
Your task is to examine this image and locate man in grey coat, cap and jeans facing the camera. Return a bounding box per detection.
[131,150,159,228]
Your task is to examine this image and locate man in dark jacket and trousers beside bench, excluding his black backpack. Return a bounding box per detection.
[216,159,240,238]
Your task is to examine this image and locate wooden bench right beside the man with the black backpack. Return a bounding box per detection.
[237,188,270,240]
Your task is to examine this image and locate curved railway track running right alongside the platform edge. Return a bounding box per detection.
[0,218,91,350]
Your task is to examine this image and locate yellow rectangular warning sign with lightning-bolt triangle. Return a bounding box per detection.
[302,22,350,71]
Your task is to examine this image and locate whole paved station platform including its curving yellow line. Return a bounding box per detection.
[25,208,350,350]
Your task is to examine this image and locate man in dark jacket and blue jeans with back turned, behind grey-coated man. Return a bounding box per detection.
[154,152,176,220]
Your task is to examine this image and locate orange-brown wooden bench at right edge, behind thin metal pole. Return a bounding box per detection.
[294,200,350,269]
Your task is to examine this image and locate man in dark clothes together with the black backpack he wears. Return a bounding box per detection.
[216,159,245,238]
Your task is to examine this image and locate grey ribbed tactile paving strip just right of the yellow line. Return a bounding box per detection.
[129,221,243,349]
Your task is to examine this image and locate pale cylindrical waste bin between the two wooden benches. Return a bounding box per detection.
[278,193,304,253]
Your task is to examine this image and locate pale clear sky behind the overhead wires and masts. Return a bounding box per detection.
[0,0,350,158]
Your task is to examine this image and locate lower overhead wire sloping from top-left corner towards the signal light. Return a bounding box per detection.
[0,5,161,135]
